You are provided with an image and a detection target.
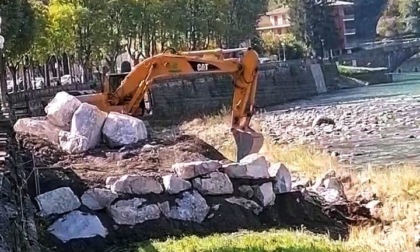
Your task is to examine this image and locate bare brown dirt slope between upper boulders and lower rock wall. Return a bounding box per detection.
[16,134,227,185]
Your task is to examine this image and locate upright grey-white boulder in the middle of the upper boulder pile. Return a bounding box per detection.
[70,103,107,149]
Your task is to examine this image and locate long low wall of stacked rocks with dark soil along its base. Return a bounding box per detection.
[32,154,380,249]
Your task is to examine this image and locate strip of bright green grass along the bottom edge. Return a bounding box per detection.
[119,230,365,252]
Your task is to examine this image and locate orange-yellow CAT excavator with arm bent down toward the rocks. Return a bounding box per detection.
[76,48,264,161]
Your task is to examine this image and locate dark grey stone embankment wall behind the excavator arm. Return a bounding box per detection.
[152,64,332,119]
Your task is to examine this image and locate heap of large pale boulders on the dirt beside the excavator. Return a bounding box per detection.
[14,91,147,154]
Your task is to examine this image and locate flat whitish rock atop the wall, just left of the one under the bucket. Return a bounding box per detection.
[172,160,222,179]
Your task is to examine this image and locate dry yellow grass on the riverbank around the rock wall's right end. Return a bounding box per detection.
[170,112,420,251]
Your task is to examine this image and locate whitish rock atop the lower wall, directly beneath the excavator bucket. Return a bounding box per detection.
[223,153,270,179]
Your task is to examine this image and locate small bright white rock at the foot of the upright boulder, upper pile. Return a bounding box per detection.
[58,131,89,154]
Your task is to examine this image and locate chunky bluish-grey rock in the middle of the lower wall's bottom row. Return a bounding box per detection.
[159,190,210,223]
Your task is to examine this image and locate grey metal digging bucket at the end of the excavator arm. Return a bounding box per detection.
[232,130,264,162]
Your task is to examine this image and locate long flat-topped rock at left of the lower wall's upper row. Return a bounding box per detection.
[111,175,163,195]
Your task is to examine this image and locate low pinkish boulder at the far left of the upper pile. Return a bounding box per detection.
[13,117,61,144]
